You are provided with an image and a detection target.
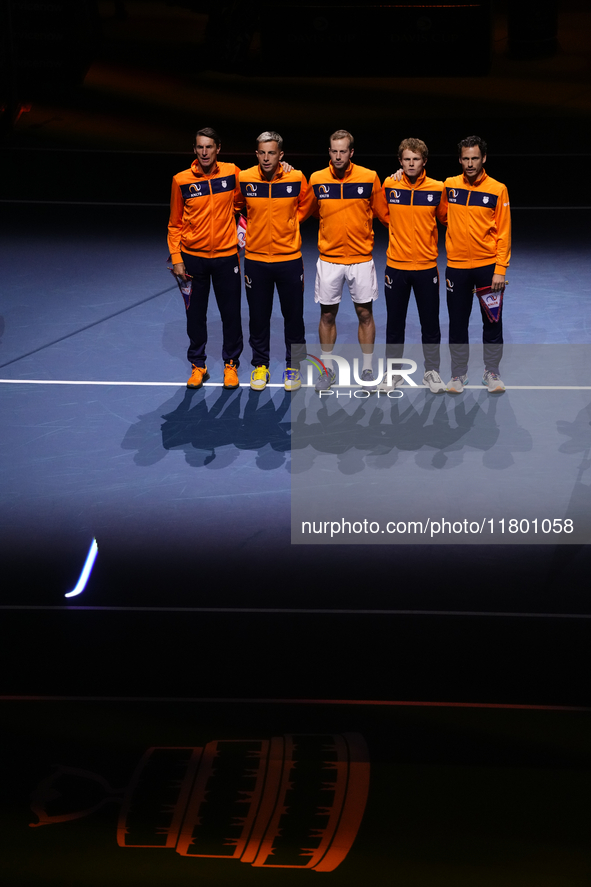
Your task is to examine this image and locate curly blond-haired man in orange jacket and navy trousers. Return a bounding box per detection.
[380,139,445,394]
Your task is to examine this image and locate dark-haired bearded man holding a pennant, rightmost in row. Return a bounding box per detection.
[439,136,511,394]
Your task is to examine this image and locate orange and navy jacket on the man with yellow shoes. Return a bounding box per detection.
[240,165,308,262]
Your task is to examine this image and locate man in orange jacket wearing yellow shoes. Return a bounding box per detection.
[239,132,307,391]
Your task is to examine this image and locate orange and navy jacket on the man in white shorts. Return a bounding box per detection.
[300,163,386,265]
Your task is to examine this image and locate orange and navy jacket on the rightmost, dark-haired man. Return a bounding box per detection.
[438,170,511,274]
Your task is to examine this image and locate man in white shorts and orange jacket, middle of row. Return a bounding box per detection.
[301,129,387,391]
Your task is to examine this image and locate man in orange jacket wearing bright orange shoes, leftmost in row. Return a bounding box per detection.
[168,126,242,388]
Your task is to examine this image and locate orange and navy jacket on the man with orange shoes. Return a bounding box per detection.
[168,160,241,265]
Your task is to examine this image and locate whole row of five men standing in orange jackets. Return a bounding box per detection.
[168,127,511,394]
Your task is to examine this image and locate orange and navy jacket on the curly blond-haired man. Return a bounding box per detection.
[380,171,443,271]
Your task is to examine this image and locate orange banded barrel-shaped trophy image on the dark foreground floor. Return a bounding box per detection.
[117,733,370,872]
